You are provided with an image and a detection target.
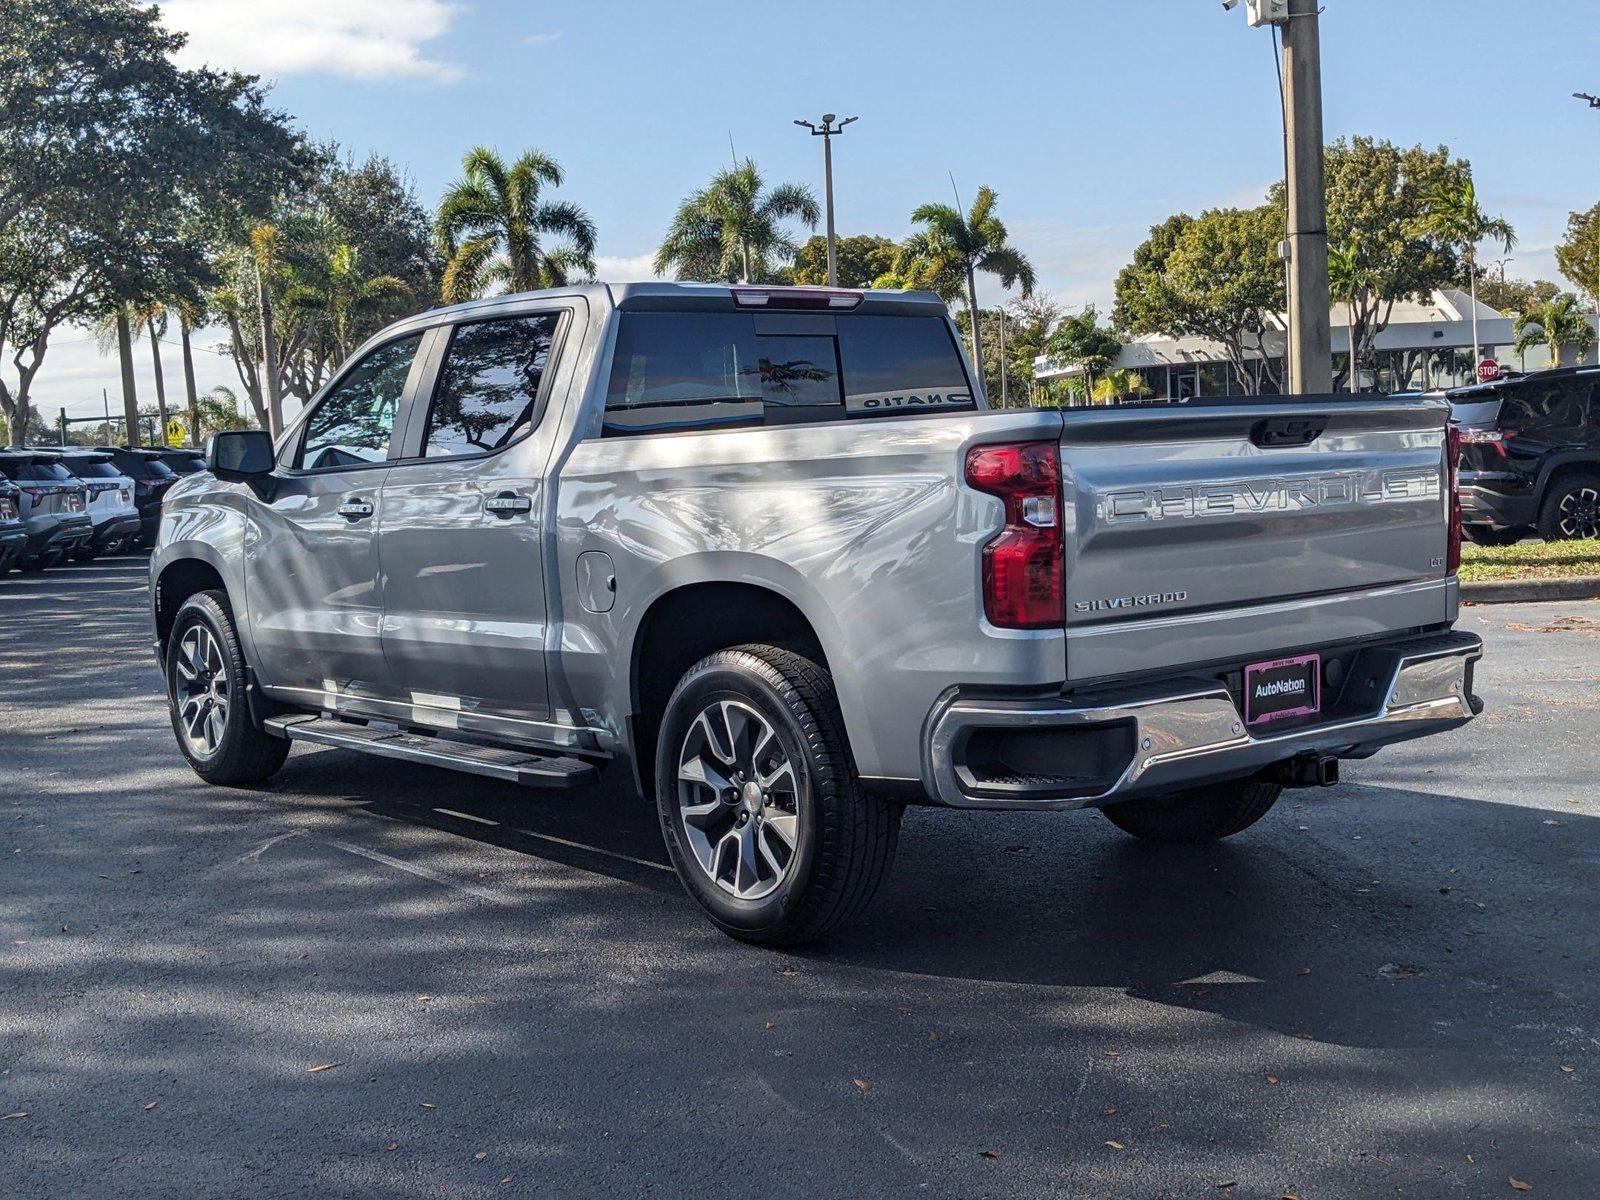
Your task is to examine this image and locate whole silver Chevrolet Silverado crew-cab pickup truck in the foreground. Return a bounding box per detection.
[150,283,1482,944]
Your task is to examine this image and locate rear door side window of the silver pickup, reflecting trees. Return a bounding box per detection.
[422,312,562,458]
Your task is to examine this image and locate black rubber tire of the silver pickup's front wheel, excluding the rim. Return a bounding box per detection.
[165,592,290,786]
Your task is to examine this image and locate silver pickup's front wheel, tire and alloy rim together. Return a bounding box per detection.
[166,592,290,784]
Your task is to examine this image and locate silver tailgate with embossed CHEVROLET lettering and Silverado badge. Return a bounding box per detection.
[1061,397,1456,682]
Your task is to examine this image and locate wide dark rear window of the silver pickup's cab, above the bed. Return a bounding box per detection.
[605,312,973,435]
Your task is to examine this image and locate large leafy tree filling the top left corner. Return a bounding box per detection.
[0,0,304,448]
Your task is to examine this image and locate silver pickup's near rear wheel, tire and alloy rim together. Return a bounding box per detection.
[656,646,901,946]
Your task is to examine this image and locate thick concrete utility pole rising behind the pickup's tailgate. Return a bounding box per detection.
[1282,0,1333,394]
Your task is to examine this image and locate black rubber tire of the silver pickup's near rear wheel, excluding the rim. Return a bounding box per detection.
[656,645,901,946]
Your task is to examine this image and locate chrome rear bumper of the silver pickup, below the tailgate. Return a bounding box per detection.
[923,632,1483,810]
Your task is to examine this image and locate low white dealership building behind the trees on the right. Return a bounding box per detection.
[1034,288,1595,400]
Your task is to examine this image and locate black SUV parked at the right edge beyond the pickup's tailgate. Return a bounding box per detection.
[1445,366,1600,546]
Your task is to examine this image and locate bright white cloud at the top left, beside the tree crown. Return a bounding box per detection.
[162,0,461,83]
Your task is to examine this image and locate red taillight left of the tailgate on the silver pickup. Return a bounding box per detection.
[966,442,1066,629]
